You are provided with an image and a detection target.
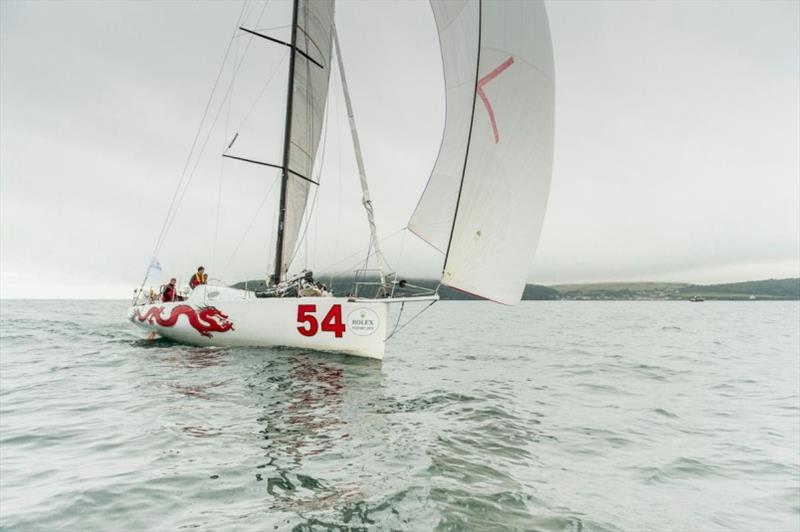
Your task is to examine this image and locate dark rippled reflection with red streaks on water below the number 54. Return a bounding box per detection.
[247,353,387,513]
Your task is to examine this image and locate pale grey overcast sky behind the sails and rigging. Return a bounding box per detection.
[0,0,800,298]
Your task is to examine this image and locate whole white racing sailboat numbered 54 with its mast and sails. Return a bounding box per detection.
[128,0,554,359]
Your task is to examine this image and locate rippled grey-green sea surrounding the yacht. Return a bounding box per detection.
[0,301,800,531]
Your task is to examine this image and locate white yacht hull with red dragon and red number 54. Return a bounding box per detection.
[128,286,389,359]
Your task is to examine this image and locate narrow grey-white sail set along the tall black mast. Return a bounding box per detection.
[281,0,334,273]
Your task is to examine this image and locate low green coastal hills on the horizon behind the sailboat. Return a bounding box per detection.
[234,274,800,301]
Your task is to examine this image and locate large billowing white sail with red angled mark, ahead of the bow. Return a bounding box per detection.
[409,0,554,304]
